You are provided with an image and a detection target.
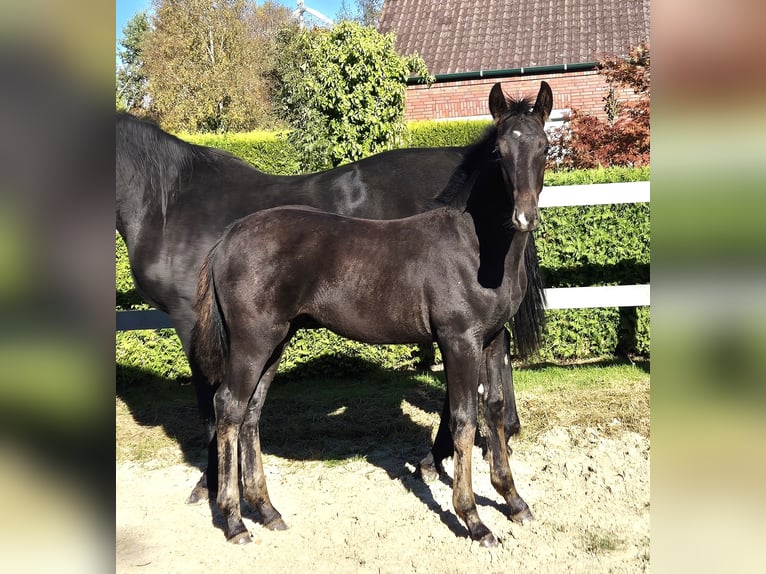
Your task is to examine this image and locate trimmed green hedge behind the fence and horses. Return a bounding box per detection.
[116,121,650,379]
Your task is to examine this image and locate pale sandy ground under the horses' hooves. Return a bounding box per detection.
[116,427,649,574]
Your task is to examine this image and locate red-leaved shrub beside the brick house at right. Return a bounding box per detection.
[553,44,651,169]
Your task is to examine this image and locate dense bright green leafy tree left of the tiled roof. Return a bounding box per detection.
[274,21,429,170]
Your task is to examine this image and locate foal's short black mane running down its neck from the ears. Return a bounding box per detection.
[427,97,533,209]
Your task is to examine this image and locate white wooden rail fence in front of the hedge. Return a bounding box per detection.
[117,181,649,331]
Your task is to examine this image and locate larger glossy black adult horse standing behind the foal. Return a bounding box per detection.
[116,85,542,502]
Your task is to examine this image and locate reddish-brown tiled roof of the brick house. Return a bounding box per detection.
[378,0,649,75]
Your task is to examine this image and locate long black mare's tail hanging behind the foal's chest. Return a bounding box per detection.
[511,233,545,358]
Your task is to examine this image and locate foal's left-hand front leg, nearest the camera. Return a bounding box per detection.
[442,338,497,546]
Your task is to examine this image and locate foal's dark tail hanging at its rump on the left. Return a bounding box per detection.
[191,243,229,384]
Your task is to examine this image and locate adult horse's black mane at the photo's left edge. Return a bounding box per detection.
[116,112,246,220]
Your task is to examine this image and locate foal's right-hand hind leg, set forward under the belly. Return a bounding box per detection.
[240,345,287,530]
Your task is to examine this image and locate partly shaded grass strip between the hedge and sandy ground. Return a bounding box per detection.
[116,361,649,466]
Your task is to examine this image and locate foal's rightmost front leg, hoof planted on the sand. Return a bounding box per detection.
[482,333,534,522]
